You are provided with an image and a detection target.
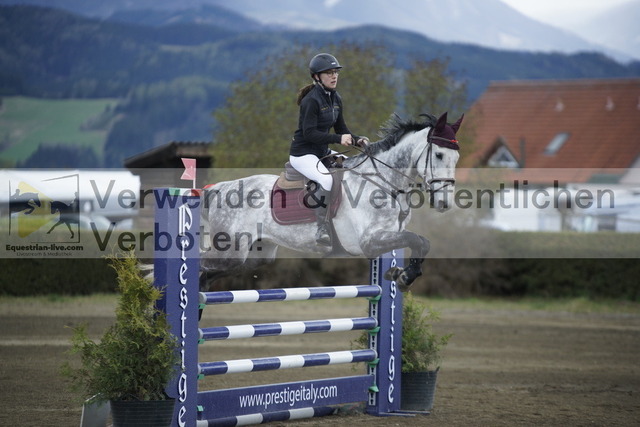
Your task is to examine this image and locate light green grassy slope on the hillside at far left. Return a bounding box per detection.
[0,96,117,165]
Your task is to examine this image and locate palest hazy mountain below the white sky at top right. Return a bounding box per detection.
[210,0,638,61]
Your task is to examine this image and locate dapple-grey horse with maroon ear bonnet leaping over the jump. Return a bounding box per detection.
[200,113,464,290]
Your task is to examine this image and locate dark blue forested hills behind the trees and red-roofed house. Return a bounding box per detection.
[0,5,640,167]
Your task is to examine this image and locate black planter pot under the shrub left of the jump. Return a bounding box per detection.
[111,399,175,427]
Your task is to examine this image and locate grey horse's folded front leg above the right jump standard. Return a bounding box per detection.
[364,231,431,292]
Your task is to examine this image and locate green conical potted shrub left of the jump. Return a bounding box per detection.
[62,253,179,401]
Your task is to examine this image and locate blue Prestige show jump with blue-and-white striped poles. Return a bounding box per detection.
[154,189,402,427]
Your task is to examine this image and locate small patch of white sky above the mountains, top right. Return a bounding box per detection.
[502,0,631,27]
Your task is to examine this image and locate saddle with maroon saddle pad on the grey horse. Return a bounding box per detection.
[271,162,343,225]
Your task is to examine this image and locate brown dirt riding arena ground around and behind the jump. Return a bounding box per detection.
[0,296,640,427]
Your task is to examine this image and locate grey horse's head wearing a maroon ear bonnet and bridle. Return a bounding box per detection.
[422,113,464,212]
